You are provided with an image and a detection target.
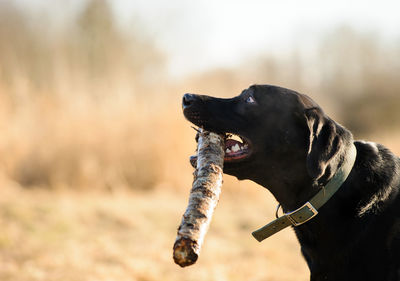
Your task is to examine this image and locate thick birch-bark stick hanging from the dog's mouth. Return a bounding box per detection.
[174,131,225,267]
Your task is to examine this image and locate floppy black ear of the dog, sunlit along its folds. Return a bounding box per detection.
[305,107,353,184]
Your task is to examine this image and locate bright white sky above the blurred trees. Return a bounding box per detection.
[12,0,400,76]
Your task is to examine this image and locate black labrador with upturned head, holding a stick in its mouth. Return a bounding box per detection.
[182,85,400,281]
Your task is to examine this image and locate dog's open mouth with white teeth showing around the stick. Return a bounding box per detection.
[190,133,251,167]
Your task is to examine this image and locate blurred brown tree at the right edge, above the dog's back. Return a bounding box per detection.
[320,26,400,135]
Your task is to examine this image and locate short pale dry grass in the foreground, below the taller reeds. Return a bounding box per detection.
[0,178,307,281]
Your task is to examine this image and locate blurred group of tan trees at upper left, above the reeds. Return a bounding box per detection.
[0,0,165,102]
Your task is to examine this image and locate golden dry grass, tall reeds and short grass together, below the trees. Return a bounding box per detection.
[0,88,314,281]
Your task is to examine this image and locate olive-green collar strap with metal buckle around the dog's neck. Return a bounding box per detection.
[252,144,357,242]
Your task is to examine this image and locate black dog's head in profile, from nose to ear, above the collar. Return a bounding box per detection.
[182,85,352,206]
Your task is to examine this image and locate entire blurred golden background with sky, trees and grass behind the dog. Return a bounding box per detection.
[0,0,400,281]
